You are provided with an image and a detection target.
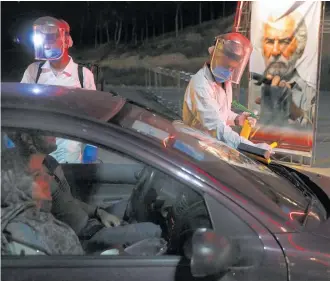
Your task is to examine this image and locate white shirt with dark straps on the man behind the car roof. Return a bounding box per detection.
[21,57,96,163]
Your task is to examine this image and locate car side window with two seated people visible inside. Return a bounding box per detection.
[1,130,212,256]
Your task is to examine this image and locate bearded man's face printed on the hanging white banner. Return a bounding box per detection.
[262,16,299,77]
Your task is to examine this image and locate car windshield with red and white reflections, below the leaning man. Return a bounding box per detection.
[111,104,324,233]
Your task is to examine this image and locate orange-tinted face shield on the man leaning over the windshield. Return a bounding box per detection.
[210,33,252,84]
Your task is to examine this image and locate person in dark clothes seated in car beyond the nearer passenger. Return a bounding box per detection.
[8,133,162,252]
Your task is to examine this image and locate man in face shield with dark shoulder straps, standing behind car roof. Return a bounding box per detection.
[21,17,96,163]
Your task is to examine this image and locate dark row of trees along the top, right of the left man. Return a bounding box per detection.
[73,1,236,46]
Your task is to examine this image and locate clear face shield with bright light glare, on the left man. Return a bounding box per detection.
[33,19,66,60]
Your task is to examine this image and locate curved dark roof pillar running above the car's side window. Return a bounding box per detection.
[1,108,302,232]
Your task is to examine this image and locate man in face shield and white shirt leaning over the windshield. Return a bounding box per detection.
[183,33,271,150]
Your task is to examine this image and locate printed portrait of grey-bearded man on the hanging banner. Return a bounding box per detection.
[254,11,316,126]
